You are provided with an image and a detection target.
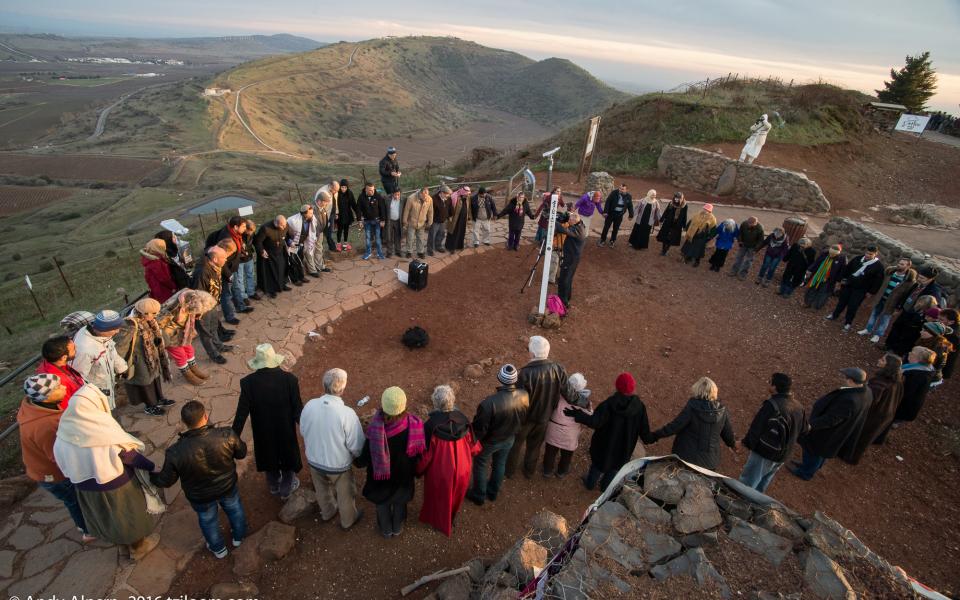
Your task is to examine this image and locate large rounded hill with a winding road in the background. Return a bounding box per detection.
[217,37,629,153]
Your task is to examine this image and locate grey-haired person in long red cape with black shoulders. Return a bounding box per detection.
[417,385,480,537]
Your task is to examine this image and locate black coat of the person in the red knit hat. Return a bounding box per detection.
[566,392,655,473]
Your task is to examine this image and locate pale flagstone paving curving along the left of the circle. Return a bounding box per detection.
[0,219,516,598]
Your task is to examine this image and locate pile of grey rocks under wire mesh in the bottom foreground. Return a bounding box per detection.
[472,458,920,600]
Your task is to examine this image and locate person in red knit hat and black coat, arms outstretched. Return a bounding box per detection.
[563,373,655,490]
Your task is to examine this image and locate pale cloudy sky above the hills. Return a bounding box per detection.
[0,0,960,114]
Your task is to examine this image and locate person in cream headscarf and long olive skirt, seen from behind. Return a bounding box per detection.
[53,384,164,560]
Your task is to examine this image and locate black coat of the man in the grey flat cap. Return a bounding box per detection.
[800,386,873,458]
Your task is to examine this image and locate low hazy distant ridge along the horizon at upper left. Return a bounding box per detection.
[0,33,326,64]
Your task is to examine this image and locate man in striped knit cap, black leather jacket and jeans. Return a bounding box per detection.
[467,364,530,506]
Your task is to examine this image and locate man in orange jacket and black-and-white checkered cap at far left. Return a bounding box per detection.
[17,373,96,543]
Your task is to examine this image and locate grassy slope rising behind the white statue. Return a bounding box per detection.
[468,81,867,174]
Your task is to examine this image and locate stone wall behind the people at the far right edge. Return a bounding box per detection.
[817,217,960,306]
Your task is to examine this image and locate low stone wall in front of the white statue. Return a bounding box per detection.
[657,145,830,213]
